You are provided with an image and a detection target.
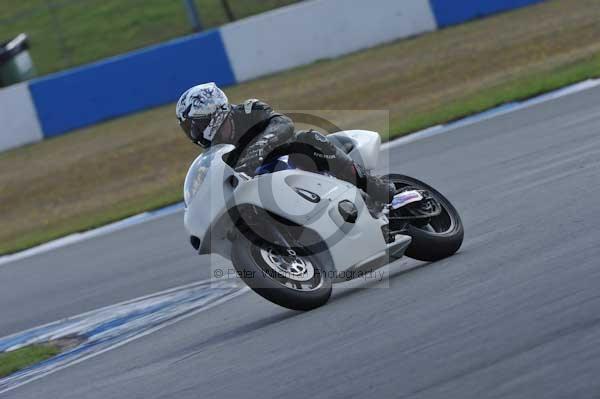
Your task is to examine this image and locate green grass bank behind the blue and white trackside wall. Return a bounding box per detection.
[0,0,298,75]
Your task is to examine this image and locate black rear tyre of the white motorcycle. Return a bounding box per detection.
[388,174,464,262]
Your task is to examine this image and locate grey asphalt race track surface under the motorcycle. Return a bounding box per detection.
[0,89,600,399]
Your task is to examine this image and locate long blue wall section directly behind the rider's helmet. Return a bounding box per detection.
[29,30,235,137]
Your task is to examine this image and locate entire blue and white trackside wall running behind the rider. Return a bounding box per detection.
[0,0,544,151]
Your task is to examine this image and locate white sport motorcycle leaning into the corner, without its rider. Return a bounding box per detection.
[184,130,464,310]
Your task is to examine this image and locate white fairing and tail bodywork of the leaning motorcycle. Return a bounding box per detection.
[184,131,410,280]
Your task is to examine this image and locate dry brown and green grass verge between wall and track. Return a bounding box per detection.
[0,0,600,254]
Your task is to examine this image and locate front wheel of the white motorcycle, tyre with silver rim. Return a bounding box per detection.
[231,235,332,311]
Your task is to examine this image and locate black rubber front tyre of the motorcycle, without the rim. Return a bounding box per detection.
[231,235,332,311]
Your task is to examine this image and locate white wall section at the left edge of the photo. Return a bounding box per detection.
[0,83,44,151]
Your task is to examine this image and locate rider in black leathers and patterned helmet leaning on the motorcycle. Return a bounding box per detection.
[176,82,395,203]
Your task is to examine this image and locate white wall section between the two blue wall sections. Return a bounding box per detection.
[221,0,437,82]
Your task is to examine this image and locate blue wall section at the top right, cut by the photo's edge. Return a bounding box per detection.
[429,0,544,28]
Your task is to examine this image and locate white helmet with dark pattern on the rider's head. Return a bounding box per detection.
[175,82,231,148]
